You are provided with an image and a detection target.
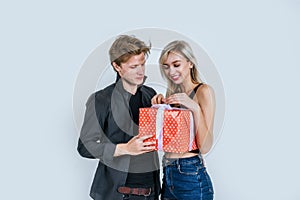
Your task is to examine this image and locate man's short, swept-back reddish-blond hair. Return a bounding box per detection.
[109,35,151,66]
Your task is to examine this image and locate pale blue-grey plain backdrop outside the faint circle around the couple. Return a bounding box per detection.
[0,0,300,200]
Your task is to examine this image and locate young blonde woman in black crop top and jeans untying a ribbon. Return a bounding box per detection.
[151,41,215,200]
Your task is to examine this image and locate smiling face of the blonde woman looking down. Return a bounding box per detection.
[162,52,193,84]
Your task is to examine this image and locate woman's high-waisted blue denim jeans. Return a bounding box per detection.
[161,154,214,200]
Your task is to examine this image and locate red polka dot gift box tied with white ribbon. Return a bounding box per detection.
[139,104,198,153]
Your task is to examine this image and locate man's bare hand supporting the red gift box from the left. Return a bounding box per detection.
[114,135,155,156]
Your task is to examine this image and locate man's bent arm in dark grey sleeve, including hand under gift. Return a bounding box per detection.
[77,95,155,162]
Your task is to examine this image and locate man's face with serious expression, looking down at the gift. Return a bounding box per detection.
[113,53,146,88]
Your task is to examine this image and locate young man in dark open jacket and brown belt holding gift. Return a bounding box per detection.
[77,35,160,200]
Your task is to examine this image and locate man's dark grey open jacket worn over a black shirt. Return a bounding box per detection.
[77,78,160,200]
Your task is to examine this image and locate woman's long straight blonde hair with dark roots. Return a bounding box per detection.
[159,40,202,97]
